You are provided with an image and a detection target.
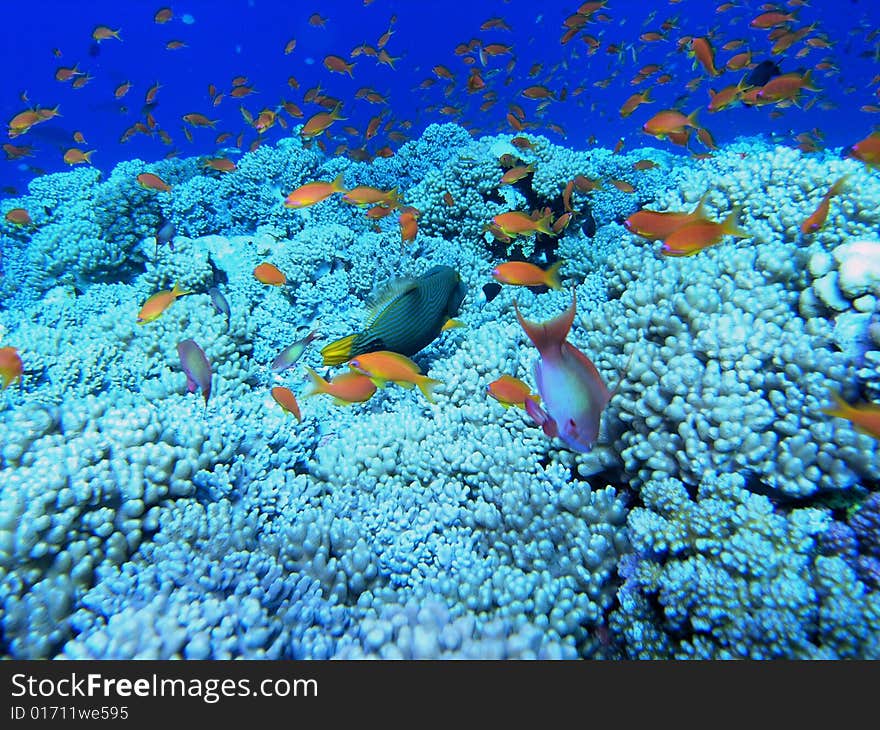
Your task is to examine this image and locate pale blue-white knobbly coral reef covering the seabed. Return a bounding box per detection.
[0,125,880,659]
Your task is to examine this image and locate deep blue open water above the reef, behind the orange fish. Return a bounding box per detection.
[0,0,880,195]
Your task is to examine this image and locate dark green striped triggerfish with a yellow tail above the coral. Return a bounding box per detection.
[321,266,465,365]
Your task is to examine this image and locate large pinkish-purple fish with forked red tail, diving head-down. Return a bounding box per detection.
[513,292,611,453]
